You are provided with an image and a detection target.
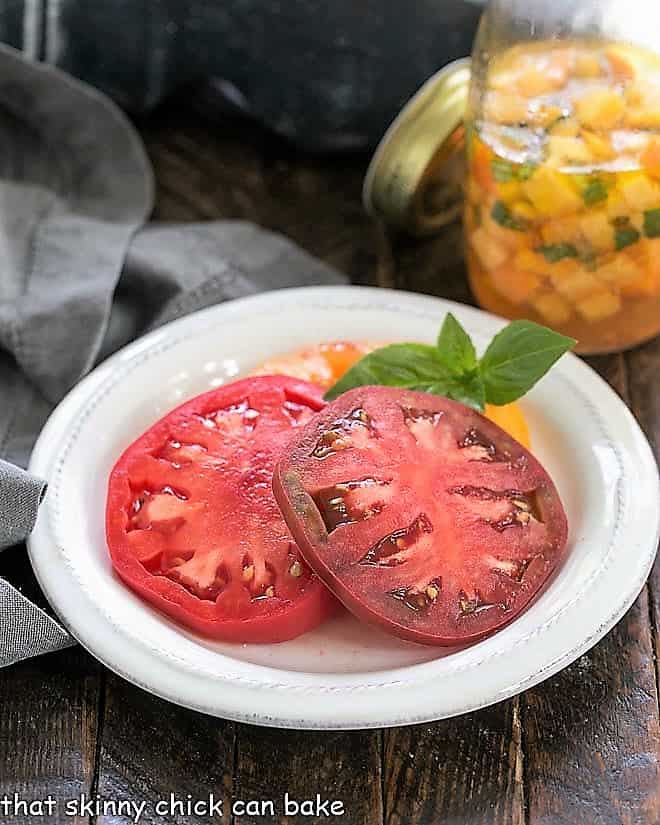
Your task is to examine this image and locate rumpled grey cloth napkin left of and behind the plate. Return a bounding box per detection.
[0,46,344,666]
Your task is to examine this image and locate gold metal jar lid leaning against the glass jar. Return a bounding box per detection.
[362,57,470,235]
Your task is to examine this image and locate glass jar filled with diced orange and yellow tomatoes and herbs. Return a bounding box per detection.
[464,0,660,352]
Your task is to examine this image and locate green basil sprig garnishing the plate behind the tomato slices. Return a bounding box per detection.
[325,313,576,410]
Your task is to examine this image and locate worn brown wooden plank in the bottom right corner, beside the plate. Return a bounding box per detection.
[522,355,660,825]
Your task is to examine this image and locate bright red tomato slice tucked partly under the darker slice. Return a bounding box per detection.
[106,376,334,642]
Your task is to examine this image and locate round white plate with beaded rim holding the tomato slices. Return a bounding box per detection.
[29,287,660,728]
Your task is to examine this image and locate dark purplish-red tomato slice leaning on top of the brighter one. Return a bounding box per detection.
[273,387,567,645]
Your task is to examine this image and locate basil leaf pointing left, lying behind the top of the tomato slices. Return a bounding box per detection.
[325,344,484,409]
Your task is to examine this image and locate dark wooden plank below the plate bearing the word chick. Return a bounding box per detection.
[92,674,235,825]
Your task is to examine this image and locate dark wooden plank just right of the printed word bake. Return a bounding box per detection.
[384,699,525,825]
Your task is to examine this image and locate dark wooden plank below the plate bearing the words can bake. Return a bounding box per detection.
[234,725,383,825]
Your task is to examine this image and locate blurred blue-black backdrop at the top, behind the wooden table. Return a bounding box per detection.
[0,0,481,151]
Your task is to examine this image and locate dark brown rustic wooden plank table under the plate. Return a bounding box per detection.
[0,105,660,825]
